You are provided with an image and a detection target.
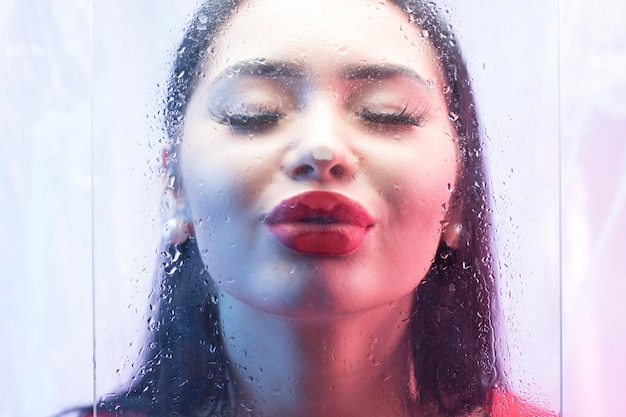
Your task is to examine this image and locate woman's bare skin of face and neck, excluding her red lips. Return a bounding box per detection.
[180,0,459,417]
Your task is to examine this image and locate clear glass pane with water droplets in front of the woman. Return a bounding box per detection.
[93,0,560,416]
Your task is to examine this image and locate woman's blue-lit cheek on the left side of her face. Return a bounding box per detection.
[180,138,280,266]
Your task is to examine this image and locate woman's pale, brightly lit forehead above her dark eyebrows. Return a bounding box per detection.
[205,0,441,81]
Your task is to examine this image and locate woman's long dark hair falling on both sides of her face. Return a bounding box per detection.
[89,0,500,416]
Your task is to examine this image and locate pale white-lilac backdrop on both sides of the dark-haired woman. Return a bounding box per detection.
[0,0,626,417]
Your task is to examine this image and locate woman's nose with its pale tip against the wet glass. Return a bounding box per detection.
[284,102,358,182]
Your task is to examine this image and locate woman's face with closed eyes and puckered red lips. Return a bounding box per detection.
[180,0,459,318]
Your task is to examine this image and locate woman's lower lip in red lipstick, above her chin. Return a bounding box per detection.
[269,223,367,256]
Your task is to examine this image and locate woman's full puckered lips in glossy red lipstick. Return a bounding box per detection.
[265,191,374,255]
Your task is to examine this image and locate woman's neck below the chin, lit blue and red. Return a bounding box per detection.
[220,294,415,417]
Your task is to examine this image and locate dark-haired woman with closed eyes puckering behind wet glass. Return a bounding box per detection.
[80,0,552,417]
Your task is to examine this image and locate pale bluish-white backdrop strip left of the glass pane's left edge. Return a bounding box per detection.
[0,0,92,417]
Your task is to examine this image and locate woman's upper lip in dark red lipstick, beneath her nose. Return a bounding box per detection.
[265,191,374,227]
